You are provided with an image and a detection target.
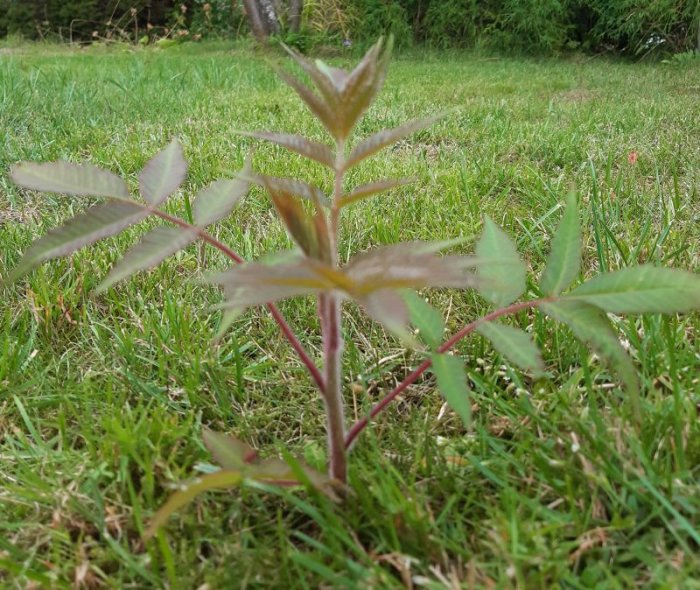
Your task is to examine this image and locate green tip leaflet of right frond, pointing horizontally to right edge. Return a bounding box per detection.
[564,265,700,313]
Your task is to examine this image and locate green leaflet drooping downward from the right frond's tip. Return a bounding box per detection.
[541,299,639,412]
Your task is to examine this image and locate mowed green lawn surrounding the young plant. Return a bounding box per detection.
[0,45,700,589]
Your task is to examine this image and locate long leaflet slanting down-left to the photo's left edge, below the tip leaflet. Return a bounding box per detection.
[8,201,149,283]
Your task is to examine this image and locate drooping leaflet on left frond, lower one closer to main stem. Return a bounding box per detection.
[96,227,197,293]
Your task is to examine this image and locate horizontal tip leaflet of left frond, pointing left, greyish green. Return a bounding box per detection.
[10,162,129,198]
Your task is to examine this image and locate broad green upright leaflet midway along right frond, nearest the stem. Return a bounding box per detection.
[476,216,527,307]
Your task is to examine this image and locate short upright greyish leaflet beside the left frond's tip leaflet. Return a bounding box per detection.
[139,139,187,206]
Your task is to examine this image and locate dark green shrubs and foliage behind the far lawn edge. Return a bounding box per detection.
[0,0,700,55]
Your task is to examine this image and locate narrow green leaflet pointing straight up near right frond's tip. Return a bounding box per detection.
[540,194,581,295]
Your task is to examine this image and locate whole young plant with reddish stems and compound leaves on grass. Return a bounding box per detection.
[8,41,700,535]
